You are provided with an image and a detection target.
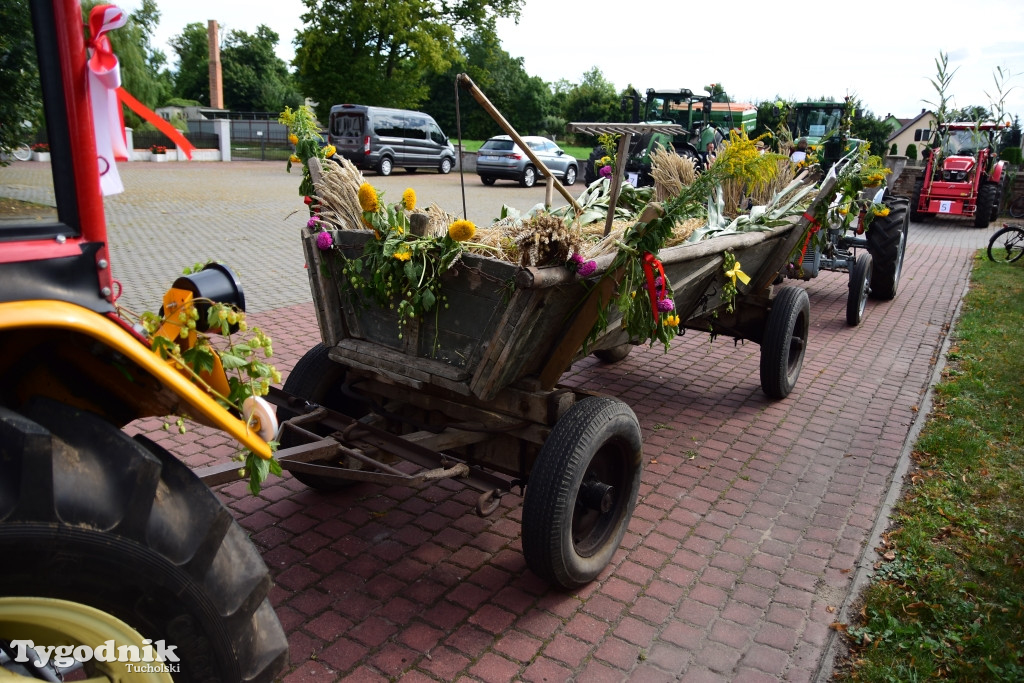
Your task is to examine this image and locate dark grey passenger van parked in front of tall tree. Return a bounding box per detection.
[327,104,455,175]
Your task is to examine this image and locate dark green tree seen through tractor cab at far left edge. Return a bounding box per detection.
[0,0,43,160]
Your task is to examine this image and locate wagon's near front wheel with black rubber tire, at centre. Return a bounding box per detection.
[522,396,643,589]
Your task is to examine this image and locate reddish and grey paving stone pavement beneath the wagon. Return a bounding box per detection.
[0,163,996,683]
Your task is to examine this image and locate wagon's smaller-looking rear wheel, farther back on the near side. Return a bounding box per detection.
[761,287,811,398]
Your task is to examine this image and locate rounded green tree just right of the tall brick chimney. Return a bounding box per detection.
[220,25,302,112]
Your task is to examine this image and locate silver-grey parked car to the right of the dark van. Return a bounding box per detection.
[476,135,580,187]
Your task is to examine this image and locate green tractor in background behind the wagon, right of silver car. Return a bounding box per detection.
[584,84,758,187]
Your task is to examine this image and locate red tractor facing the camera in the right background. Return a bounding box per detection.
[910,122,1007,227]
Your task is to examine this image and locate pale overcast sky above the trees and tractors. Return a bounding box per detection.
[138,0,1024,118]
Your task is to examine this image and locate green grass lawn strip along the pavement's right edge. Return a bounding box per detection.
[837,253,1024,683]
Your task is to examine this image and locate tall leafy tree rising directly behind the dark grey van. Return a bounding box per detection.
[294,0,523,120]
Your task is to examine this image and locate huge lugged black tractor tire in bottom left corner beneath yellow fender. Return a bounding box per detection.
[0,398,288,682]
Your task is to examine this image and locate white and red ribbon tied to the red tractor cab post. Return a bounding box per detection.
[88,5,196,196]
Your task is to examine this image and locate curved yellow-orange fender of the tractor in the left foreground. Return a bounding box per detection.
[0,300,271,459]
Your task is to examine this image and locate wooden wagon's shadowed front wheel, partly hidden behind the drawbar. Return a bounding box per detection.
[281,344,367,490]
